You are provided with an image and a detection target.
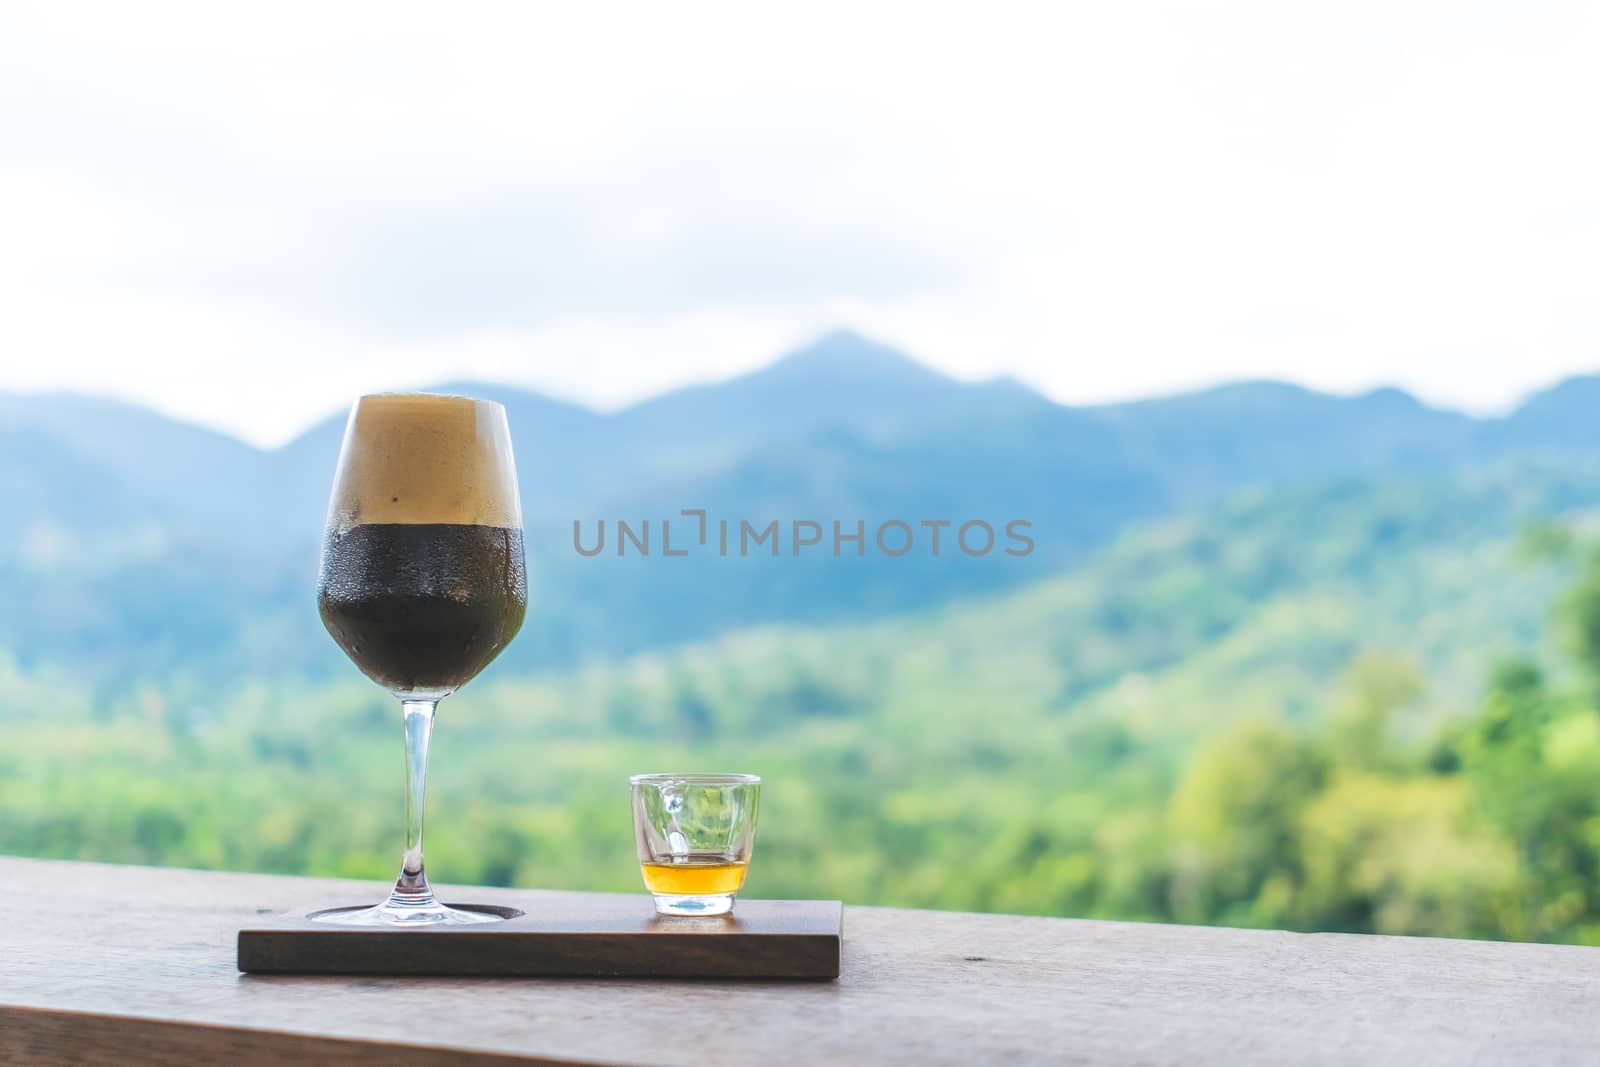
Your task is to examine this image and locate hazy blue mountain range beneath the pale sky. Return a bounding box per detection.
[0,333,1600,680]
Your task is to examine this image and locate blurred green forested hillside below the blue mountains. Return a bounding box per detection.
[9,470,1600,944]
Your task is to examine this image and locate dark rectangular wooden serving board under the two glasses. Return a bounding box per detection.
[238,893,845,979]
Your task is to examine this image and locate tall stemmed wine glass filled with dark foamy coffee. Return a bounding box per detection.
[317,394,528,926]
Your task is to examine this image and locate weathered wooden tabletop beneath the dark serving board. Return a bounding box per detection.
[0,859,1600,1067]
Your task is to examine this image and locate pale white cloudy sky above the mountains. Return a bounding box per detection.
[0,0,1600,442]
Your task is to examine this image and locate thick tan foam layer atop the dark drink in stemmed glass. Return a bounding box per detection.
[328,394,522,530]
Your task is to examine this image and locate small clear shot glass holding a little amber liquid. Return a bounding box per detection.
[629,774,762,915]
